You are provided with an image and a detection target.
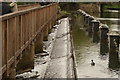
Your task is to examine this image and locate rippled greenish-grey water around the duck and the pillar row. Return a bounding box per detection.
[70,10,120,78]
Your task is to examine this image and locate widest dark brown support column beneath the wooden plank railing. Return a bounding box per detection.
[17,41,35,73]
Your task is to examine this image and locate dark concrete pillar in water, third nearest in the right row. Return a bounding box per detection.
[92,20,100,43]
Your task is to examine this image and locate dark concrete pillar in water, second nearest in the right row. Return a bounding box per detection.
[100,25,109,55]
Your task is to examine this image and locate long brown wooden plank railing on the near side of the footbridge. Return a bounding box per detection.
[0,3,58,73]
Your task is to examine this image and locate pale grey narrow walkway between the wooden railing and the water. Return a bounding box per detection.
[45,18,74,78]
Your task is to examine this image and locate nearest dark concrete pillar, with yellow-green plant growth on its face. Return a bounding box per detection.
[109,32,119,69]
